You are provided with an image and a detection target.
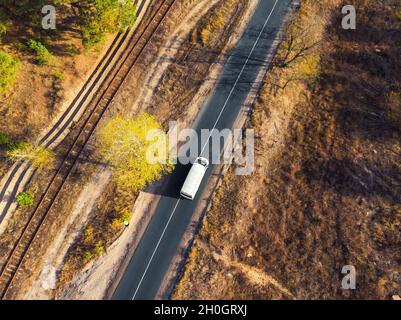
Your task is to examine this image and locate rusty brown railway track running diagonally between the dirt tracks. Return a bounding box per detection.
[0,0,176,299]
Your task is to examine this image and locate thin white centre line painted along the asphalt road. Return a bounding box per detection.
[132,0,279,300]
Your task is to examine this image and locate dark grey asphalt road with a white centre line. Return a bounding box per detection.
[112,0,291,300]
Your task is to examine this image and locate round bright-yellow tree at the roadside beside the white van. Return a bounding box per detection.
[98,113,174,191]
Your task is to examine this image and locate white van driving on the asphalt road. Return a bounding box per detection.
[181,157,209,200]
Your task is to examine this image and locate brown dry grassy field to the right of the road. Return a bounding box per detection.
[173,0,401,299]
